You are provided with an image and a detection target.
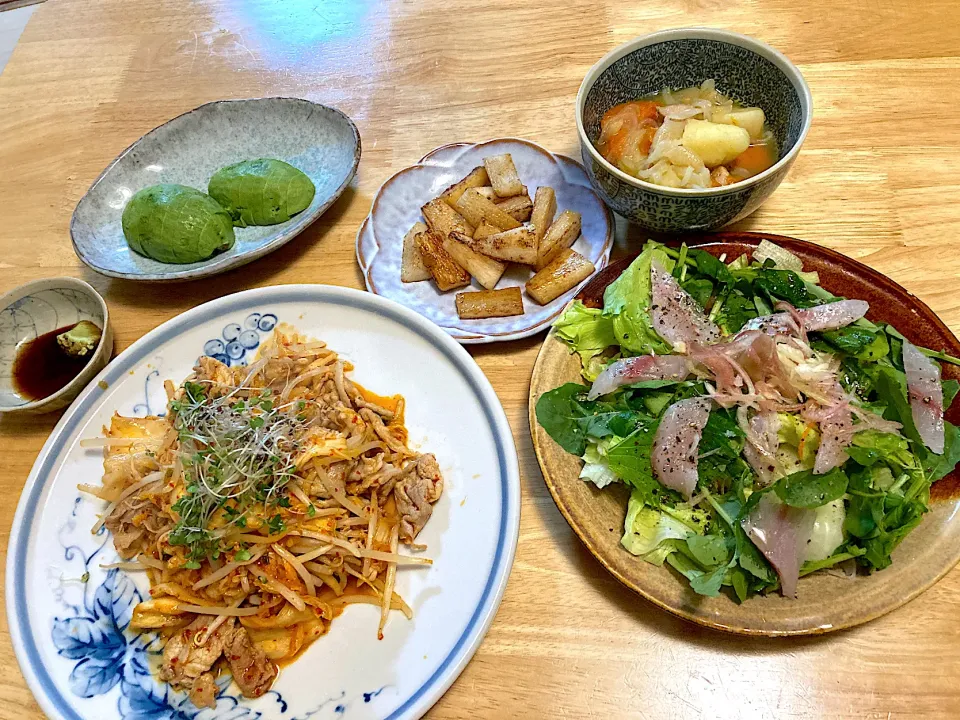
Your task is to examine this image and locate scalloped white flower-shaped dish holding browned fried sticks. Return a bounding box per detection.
[357,138,614,343]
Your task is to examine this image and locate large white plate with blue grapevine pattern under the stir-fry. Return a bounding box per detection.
[6,285,520,720]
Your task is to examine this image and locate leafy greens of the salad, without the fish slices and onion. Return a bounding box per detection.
[536,241,960,601]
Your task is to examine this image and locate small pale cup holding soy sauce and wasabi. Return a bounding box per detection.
[0,277,113,415]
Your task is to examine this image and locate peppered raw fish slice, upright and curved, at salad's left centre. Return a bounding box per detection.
[650,398,710,500]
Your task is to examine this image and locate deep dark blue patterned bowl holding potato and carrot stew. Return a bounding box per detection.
[577,28,813,232]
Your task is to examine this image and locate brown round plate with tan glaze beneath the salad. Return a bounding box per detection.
[529,233,960,636]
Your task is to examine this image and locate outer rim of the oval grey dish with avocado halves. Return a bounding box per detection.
[70,95,363,283]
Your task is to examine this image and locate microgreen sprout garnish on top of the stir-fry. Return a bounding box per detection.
[170,374,307,568]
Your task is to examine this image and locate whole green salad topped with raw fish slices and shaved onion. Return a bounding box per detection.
[536,241,960,601]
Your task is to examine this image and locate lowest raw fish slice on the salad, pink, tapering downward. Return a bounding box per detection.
[741,492,817,598]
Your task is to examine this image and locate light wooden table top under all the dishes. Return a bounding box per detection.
[0,0,960,720]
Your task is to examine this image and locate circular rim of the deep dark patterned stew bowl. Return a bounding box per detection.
[576,27,813,197]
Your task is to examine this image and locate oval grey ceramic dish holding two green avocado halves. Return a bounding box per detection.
[70,98,360,282]
